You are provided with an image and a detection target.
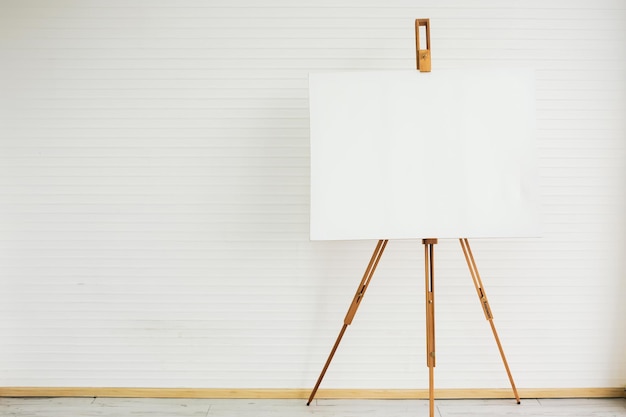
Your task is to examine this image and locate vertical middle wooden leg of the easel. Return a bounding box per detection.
[422,239,437,417]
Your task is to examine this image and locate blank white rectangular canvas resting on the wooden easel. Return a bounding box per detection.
[309,69,539,240]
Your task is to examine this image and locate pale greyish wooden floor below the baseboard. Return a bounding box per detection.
[0,397,626,417]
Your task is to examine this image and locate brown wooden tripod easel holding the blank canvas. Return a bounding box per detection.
[307,19,520,417]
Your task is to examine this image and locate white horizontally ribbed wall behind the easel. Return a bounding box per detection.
[0,0,626,388]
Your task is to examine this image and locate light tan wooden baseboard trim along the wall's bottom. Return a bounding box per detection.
[0,387,626,399]
